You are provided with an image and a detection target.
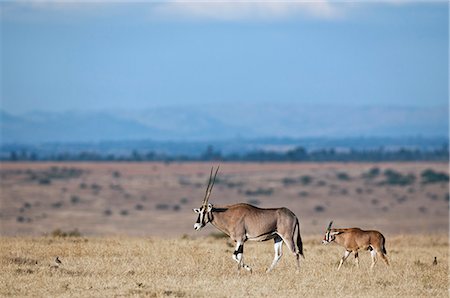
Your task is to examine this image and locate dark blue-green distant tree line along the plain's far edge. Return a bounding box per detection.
[0,145,449,162]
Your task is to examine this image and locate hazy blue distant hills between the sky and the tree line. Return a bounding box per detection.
[0,103,448,144]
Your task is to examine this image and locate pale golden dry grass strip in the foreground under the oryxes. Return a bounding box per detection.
[0,235,449,297]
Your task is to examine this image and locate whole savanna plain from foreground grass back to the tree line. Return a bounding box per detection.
[0,162,449,297]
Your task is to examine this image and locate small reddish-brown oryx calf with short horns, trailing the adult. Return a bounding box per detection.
[322,222,389,270]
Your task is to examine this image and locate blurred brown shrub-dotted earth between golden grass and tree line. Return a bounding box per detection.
[0,162,449,237]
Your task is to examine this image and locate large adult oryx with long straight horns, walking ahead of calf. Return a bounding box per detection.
[193,167,303,272]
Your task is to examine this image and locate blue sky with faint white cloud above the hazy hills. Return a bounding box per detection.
[0,0,449,113]
